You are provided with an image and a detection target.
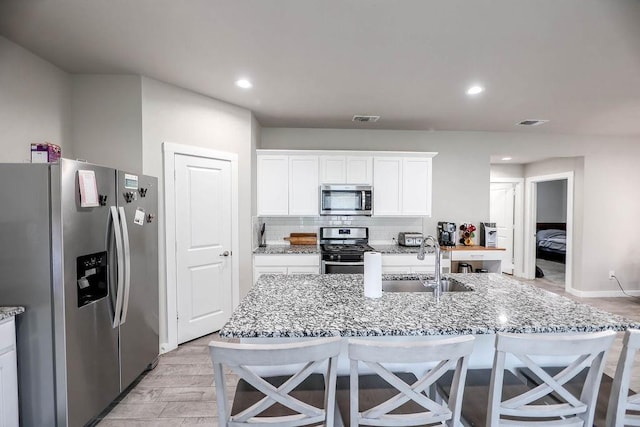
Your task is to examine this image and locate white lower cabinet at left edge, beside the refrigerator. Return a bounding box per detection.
[0,317,18,426]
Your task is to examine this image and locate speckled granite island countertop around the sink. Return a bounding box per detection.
[220,273,640,338]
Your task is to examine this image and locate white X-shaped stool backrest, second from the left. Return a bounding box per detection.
[349,336,474,426]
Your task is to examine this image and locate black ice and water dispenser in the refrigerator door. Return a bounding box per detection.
[76,251,108,307]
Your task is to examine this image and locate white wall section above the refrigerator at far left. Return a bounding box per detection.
[0,36,73,163]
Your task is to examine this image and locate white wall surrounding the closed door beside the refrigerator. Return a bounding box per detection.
[142,77,258,350]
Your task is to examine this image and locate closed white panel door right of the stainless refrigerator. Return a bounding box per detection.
[175,154,233,343]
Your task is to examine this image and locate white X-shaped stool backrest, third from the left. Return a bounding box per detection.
[487,331,616,427]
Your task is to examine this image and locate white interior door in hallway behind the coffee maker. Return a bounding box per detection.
[489,182,516,274]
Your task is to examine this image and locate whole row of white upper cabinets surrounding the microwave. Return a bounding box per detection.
[257,150,437,216]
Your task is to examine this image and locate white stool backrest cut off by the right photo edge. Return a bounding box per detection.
[607,329,640,427]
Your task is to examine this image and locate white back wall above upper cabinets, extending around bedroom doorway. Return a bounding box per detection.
[260,128,640,292]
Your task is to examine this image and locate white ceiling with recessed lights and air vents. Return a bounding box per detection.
[0,0,640,136]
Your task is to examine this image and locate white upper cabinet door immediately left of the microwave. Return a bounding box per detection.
[289,156,320,216]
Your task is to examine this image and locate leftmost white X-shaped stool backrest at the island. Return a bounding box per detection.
[209,337,341,426]
